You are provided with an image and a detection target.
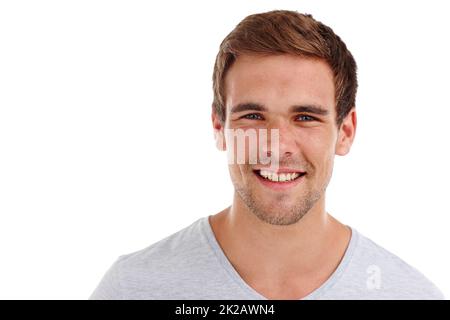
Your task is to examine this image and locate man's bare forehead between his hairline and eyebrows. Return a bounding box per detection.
[225,55,335,114]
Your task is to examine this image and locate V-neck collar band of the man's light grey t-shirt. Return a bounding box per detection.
[200,216,359,300]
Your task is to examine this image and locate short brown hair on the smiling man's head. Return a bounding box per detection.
[213,10,358,126]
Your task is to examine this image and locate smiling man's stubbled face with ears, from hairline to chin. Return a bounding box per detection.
[213,55,356,225]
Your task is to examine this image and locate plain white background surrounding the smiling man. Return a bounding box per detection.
[0,0,450,299]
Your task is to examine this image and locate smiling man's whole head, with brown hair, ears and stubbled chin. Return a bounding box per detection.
[212,10,357,225]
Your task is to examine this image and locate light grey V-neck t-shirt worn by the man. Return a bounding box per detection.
[89,216,444,300]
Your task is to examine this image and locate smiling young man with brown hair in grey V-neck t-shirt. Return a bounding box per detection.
[90,10,443,299]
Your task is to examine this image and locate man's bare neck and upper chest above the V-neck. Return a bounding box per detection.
[210,197,351,296]
